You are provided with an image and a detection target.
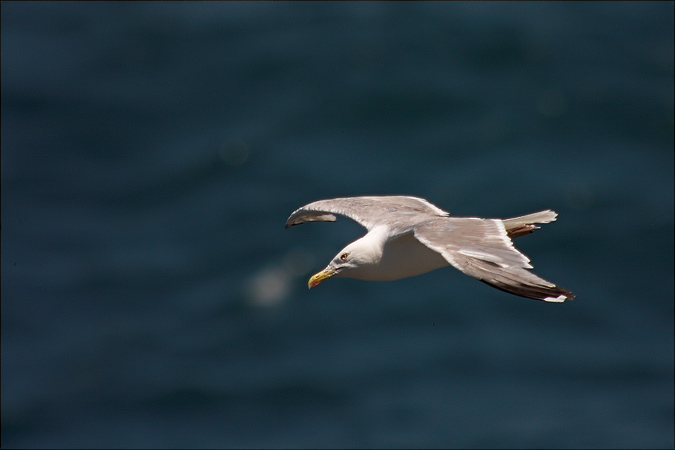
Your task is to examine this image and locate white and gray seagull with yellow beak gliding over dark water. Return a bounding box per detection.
[286,196,575,303]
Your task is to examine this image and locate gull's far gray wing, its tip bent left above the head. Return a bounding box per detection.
[286,196,448,234]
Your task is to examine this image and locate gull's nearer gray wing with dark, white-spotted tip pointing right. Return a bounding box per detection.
[415,217,574,302]
